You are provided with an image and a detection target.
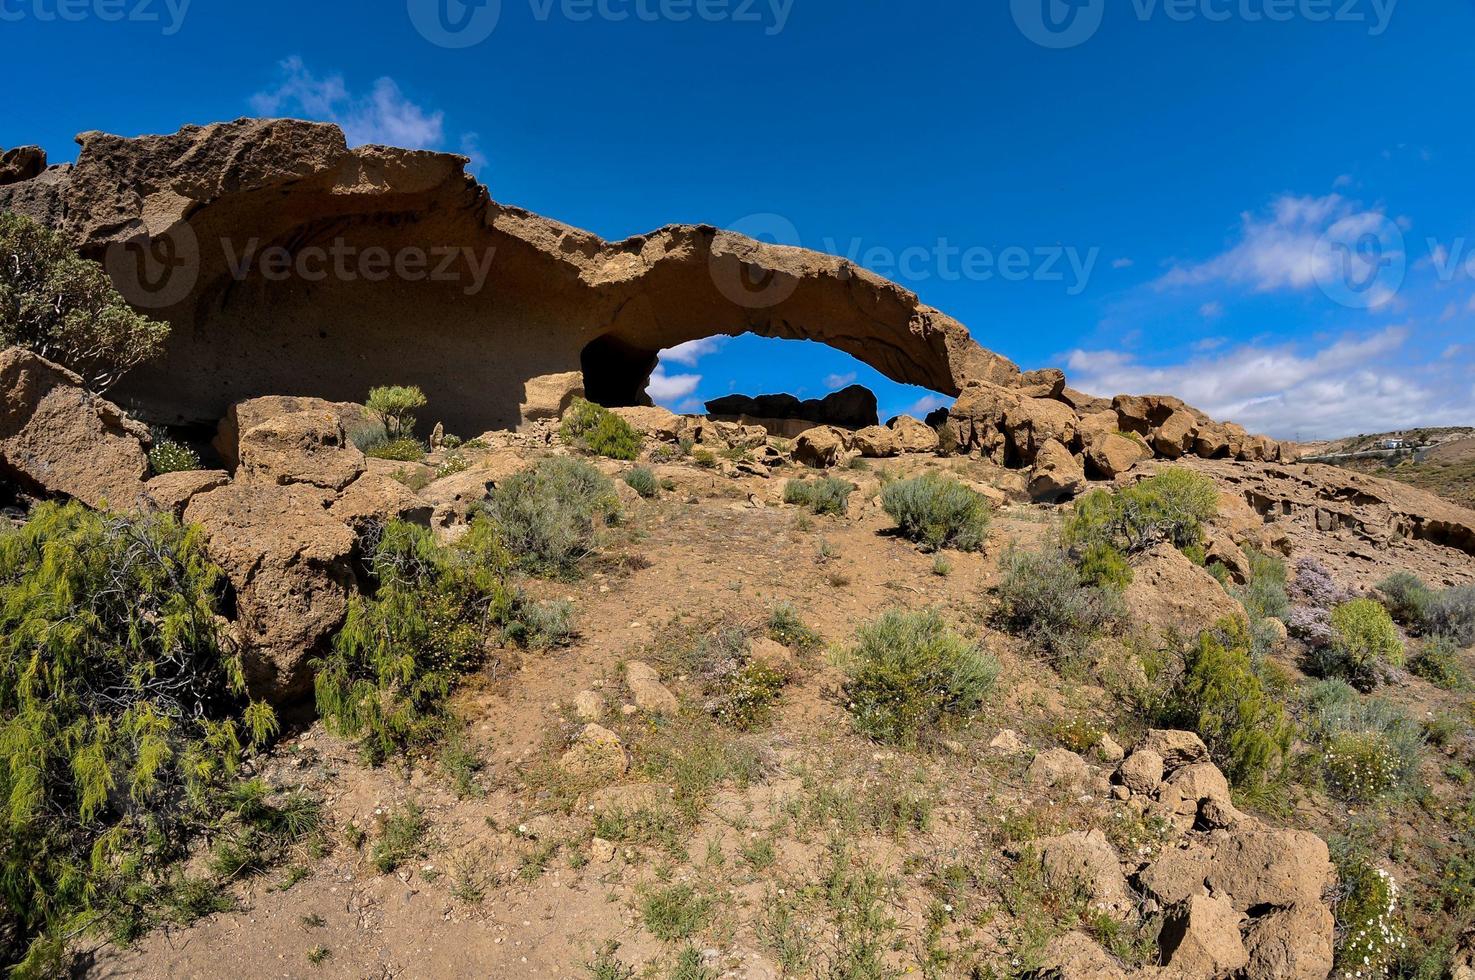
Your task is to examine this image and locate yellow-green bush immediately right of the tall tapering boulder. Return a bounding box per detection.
[316,518,516,763]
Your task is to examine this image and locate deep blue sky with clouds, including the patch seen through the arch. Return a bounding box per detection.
[0,0,1475,438]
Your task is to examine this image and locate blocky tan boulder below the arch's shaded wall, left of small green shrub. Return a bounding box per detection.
[236,409,364,491]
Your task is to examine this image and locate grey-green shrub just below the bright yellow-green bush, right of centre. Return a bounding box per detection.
[997,549,1125,663]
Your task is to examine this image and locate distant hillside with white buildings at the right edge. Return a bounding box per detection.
[1301,428,1475,509]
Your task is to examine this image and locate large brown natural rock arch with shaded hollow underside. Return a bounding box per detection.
[0,120,1019,434]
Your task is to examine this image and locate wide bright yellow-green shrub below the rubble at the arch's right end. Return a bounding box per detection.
[1062,469,1218,555]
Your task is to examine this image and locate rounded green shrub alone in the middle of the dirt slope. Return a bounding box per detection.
[842,610,999,744]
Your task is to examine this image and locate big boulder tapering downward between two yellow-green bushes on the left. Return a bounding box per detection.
[184,483,355,703]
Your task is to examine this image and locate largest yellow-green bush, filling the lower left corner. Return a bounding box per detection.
[0,503,277,976]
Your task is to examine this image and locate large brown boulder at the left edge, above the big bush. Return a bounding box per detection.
[0,347,149,509]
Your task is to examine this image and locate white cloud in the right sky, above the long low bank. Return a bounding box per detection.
[1156,193,1397,308]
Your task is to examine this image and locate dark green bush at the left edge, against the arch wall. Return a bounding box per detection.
[0,211,170,391]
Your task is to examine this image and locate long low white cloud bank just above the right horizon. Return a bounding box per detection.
[1068,326,1475,438]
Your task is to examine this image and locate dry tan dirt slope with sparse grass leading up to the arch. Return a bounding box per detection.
[77,458,1469,980]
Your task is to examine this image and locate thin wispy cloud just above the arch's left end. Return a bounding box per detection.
[251,58,463,154]
